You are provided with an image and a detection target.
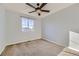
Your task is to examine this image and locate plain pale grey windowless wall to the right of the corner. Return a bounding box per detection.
[42,4,79,47]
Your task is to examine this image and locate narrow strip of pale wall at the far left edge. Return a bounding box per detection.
[0,6,6,53]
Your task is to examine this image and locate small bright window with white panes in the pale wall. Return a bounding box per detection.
[21,17,34,32]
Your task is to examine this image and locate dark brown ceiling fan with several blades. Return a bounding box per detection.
[25,3,50,16]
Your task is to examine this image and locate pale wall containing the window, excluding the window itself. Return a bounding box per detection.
[6,10,41,44]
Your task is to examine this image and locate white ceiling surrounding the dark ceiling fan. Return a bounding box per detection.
[1,3,72,18]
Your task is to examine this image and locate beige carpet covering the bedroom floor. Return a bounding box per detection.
[1,39,64,56]
